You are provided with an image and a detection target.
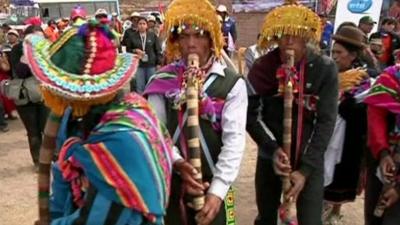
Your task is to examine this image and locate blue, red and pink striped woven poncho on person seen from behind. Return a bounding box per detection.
[58,94,172,223]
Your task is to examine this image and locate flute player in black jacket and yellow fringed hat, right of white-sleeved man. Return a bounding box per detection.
[247,1,338,225]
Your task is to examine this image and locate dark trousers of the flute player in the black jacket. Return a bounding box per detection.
[254,157,324,225]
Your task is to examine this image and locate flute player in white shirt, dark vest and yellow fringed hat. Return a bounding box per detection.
[145,0,247,225]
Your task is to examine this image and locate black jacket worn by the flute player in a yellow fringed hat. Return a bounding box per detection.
[247,49,338,177]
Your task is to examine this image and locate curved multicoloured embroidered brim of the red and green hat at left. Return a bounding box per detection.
[24,35,138,101]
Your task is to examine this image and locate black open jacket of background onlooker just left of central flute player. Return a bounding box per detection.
[124,32,162,67]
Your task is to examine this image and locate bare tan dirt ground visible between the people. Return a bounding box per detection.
[0,120,364,225]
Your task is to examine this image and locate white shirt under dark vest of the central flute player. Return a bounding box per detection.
[148,61,248,199]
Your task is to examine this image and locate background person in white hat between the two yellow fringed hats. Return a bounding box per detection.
[217,4,237,56]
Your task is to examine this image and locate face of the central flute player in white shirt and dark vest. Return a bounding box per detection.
[178,26,211,66]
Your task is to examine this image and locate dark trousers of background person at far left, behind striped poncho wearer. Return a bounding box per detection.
[17,103,49,165]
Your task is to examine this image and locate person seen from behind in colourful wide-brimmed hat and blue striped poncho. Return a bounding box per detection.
[24,21,172,225]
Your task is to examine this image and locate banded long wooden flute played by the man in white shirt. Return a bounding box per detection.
[186,54,205,211]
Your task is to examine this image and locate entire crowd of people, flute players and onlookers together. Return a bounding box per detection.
[0,0,400,225]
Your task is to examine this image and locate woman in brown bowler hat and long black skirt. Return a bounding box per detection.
[324,26,371,224]
